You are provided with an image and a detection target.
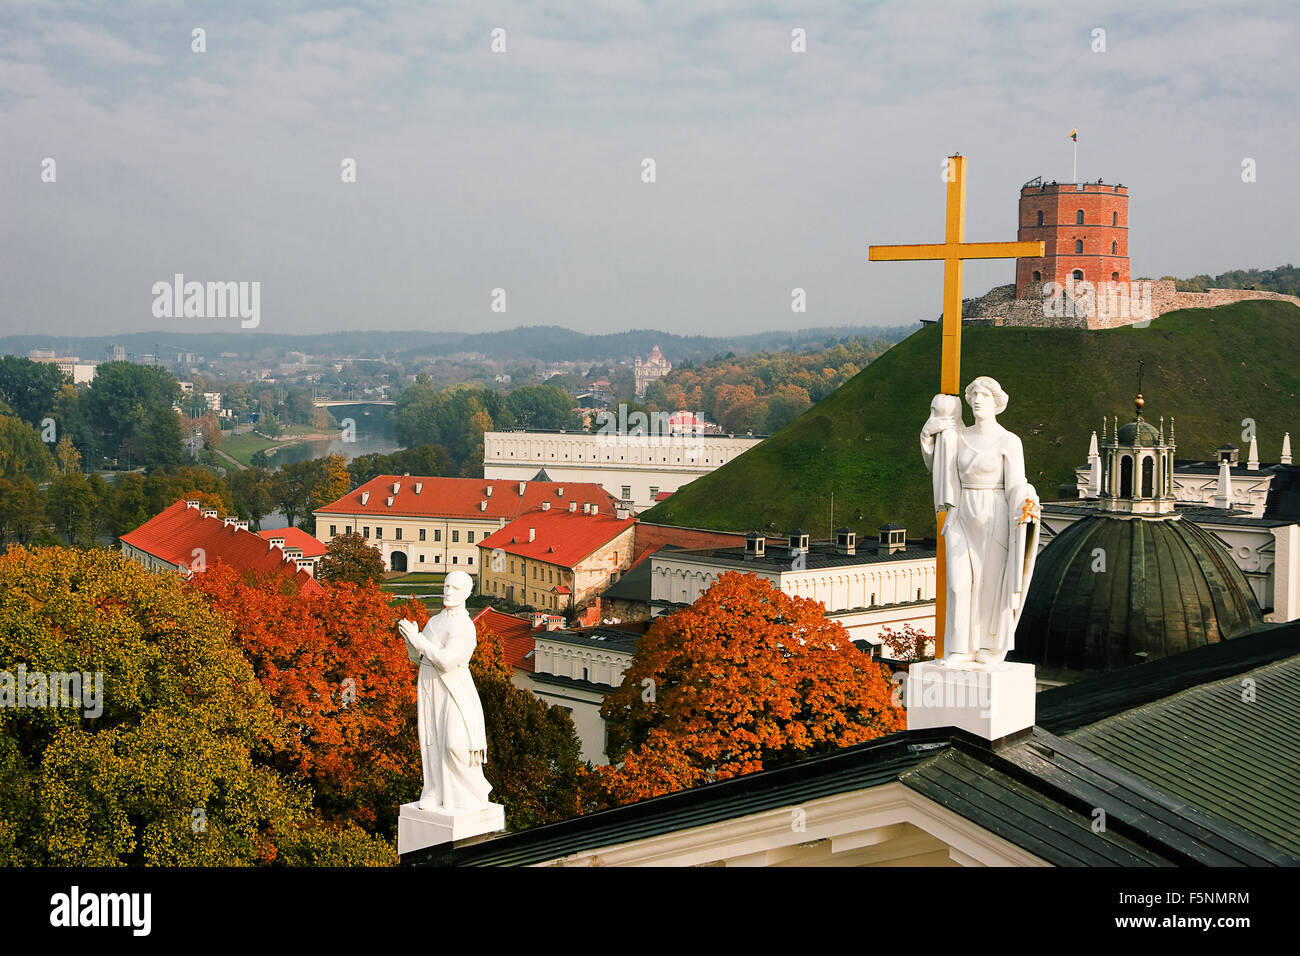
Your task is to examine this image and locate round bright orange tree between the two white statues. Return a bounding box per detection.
[601,572,905,805]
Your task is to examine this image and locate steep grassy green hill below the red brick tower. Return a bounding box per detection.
[642,300,1300,538]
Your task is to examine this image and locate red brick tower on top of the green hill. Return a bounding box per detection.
[1015,178,1128,299]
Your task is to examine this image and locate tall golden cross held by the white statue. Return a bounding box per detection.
[867,156,1044,658]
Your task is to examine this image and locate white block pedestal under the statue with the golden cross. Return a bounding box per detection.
[907,661,1036,740]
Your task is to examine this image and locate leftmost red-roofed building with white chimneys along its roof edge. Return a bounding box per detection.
[122,499,320,592]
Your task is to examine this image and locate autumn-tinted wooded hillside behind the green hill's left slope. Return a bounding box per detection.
[646,337,892,434]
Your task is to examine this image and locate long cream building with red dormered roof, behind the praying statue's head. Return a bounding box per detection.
[313,475,615,574]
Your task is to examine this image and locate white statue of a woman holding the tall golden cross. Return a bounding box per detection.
[920,375,1041,666]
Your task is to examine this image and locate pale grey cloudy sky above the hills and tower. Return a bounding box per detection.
[0,0,1300,336]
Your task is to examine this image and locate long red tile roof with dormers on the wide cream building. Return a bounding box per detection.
[316,475,616,520]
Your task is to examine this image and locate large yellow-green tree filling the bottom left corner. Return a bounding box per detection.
[0,548,395,866]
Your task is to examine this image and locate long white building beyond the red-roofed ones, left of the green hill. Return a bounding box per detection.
[484,429,763,511]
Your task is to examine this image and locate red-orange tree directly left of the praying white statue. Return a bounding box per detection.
[190,564,420,836]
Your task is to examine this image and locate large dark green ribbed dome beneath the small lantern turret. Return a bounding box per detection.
[1009,515,1261,671]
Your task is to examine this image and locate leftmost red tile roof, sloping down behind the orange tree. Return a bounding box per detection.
[122,499,321,592]
